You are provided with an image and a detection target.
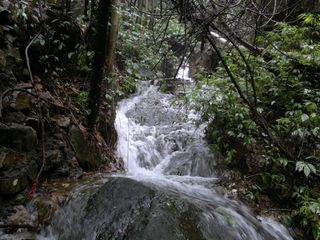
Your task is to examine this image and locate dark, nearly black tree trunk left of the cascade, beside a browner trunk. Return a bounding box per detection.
[88,0,112,132]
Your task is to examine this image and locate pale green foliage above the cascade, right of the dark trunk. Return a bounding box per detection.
[117,4,182,94]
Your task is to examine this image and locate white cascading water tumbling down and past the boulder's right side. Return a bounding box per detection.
[116,65,292,240]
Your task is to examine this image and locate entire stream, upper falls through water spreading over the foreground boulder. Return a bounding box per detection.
[37,64,293,240]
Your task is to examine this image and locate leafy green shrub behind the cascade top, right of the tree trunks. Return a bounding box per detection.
[117,4,178,80]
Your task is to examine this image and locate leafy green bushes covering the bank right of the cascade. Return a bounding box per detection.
[191,14,320,239]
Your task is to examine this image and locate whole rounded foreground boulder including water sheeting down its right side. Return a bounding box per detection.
[51,177,292,240]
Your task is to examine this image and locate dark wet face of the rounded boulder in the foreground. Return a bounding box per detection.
[53,178,205,240]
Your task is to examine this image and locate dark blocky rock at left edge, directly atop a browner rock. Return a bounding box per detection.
[0,124,37,152]
